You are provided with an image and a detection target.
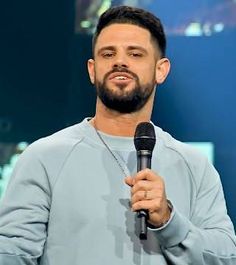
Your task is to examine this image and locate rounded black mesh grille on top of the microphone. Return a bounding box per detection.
[134,122,156,152]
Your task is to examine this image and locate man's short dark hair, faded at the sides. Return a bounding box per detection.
[92,6,166,57]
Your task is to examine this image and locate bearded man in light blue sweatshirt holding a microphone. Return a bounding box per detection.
[0,6,236,265]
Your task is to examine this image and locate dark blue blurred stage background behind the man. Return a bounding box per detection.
[0,0,236,225]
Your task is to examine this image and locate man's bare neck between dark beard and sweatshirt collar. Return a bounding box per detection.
[91,99,151,137]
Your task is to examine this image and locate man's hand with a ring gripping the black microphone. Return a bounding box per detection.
[125,169,171,227]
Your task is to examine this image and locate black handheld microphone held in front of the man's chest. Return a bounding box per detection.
[134,122,156,239]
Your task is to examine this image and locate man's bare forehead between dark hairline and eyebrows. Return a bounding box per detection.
[95,23,153,51]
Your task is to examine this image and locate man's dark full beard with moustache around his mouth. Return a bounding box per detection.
[95,68,155,113]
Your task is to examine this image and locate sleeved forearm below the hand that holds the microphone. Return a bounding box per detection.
[151,210,236,265]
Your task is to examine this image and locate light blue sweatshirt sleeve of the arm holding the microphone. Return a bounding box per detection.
[150,158,236,265]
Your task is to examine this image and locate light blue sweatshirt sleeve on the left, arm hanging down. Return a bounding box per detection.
[0,143,51,265]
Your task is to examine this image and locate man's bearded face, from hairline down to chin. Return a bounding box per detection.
[89,24,160,113]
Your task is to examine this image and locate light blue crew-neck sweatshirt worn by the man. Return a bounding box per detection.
[0,119,236,265]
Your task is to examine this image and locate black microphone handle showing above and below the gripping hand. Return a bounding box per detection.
[137,150,152,240]
